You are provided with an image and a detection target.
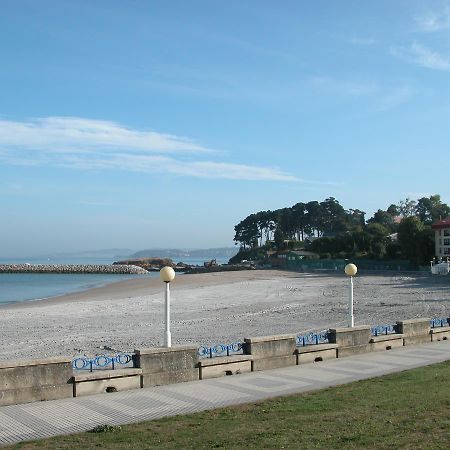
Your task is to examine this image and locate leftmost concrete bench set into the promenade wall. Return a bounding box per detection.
[72,368,142,397]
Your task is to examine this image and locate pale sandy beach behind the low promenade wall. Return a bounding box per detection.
[0,270,450,360]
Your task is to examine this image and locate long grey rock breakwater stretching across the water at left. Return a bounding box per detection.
[0,264,148,275]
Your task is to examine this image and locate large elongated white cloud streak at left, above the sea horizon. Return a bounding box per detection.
[0,117,302,183]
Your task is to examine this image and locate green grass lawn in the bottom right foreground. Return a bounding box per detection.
[8,362,450,450]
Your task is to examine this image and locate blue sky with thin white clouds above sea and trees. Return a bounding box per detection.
[0,0,450,256]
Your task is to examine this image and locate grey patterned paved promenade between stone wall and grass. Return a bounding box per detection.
[0,341,450,444]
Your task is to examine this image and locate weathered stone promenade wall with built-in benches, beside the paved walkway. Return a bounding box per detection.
[0,318,450,405]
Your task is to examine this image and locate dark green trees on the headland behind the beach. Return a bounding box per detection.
[234,194,450,264]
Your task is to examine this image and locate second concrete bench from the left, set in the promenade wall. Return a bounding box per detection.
[198,355,253,380]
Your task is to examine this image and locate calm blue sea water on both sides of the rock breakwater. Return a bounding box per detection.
[0,257,228,306]
